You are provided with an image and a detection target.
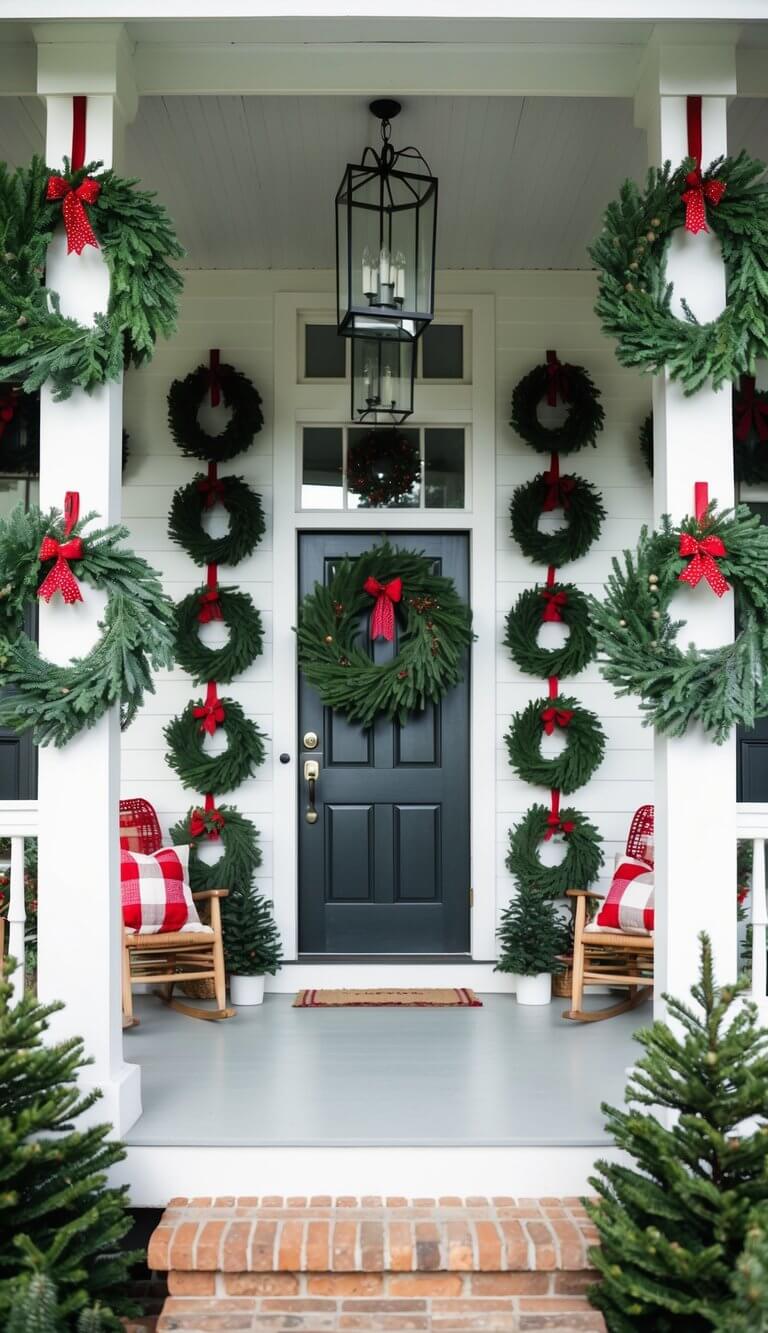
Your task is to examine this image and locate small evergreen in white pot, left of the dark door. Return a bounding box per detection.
[221,886,283,1005]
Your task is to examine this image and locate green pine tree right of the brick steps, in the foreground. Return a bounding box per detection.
[588,936,768,1333]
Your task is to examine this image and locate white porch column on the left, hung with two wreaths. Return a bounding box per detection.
[36,25,141,1134]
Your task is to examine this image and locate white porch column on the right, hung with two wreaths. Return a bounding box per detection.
[639,29,736,1016]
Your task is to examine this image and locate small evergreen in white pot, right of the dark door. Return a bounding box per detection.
[496,885,567,1004]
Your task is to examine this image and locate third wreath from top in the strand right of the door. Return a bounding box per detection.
[504,583,597,678]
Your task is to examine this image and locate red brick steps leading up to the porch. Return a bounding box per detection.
[148,1196,605,1333]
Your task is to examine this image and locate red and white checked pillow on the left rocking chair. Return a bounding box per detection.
[120,846,207,934]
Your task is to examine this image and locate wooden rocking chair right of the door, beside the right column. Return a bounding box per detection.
[563,805,653,1022]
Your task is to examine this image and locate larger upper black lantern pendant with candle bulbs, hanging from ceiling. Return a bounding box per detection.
[336,99,437,343]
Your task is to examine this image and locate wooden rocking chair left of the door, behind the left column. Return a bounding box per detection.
[120,798,235,1028]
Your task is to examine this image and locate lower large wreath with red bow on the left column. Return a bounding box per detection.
[0,505,173,746]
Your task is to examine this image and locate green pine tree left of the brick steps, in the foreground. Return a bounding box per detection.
[0,960,136,1329]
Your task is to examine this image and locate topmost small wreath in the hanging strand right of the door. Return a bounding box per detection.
[509,363,605,453]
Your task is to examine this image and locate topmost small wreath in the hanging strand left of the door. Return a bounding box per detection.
[168,363,264,463]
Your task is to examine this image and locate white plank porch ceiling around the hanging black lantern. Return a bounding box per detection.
[0,96,768,269]
